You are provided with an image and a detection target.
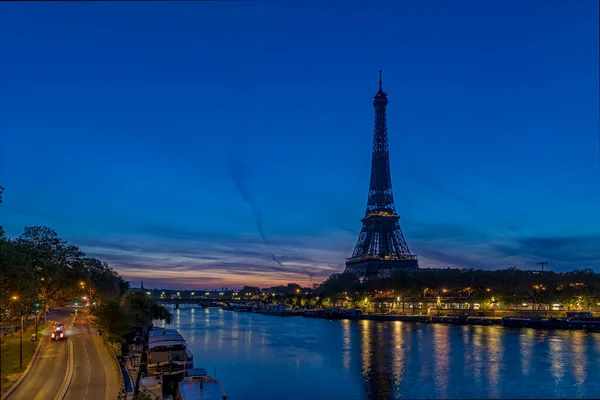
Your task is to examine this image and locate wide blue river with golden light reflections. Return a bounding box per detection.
[161,306,600,400]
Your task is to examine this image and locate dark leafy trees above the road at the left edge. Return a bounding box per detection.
[0,226,129,320]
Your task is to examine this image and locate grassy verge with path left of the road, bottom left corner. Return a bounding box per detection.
[0,324,46,393]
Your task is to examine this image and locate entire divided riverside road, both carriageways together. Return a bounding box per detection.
[7,309,119,400]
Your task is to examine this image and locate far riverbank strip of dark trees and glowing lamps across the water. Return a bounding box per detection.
[145,267,600,316]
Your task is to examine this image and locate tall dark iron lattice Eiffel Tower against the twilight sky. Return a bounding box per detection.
[344,71,419,278]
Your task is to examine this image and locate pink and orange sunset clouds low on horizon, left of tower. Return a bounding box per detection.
[80,234,343,288]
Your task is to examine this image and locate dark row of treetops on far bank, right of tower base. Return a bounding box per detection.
[317,268,600,304]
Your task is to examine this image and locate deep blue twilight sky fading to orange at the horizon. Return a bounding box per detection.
[0,0,600,288]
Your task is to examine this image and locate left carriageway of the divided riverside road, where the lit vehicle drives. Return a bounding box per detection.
[8,309,73,400]
